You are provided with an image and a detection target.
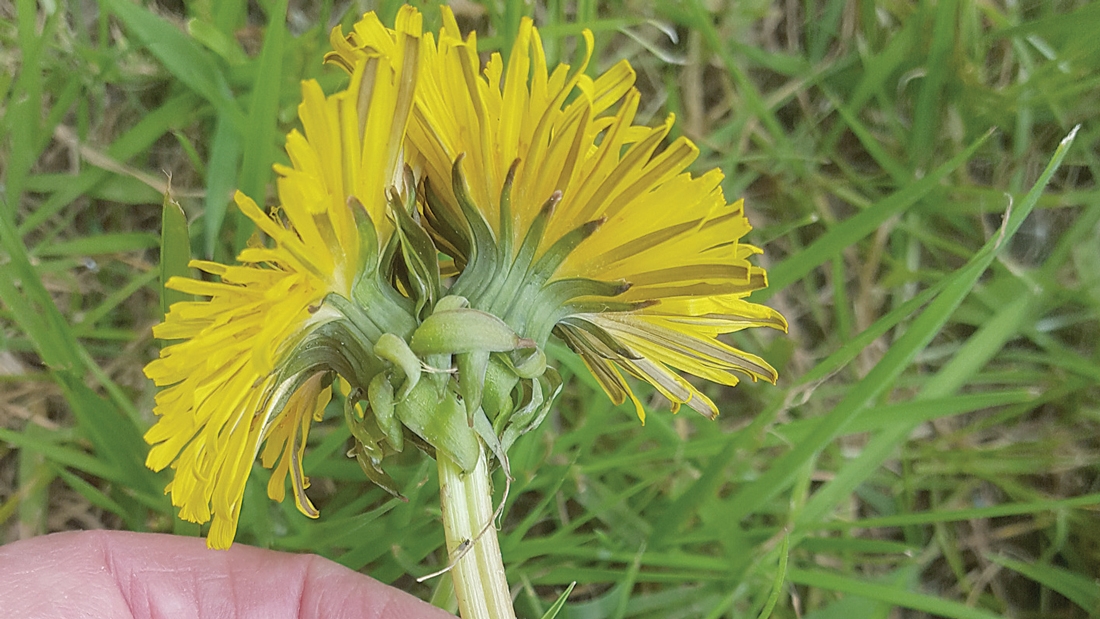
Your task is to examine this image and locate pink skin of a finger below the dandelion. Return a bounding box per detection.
[0,531,454,619]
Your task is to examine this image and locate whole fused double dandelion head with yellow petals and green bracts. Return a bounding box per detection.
[145,7,787,548]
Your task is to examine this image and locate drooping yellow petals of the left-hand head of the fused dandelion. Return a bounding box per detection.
[145,4,421,548]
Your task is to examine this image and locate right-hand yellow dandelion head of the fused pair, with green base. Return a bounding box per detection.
[337,7,787,420]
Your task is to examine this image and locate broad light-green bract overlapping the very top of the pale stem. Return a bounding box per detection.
[397,380,481,471]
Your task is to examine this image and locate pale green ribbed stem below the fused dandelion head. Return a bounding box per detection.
[436,447,516,619]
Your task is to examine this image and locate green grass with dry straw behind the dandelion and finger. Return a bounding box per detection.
[0,0,1100,619]
